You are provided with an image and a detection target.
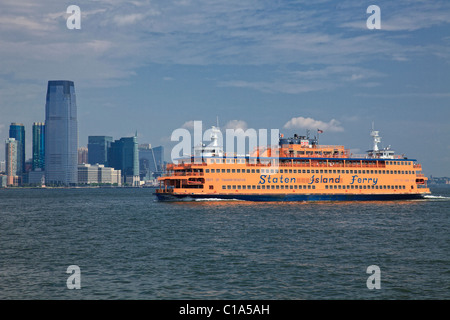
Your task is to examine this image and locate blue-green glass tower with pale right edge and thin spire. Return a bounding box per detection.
[108,136,139,186]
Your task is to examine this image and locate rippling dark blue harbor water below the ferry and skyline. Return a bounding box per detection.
[0,187,450,300]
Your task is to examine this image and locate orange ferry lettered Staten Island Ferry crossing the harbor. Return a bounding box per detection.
[155,127,430,201]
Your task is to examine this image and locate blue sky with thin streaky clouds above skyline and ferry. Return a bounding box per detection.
[0,0,450,176]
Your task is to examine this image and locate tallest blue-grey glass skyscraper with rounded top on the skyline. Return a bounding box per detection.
[45,80,78,185]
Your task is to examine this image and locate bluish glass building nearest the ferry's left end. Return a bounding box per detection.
[139,144,164,180]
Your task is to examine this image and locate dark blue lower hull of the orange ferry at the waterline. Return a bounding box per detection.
[155,193,424,202]
